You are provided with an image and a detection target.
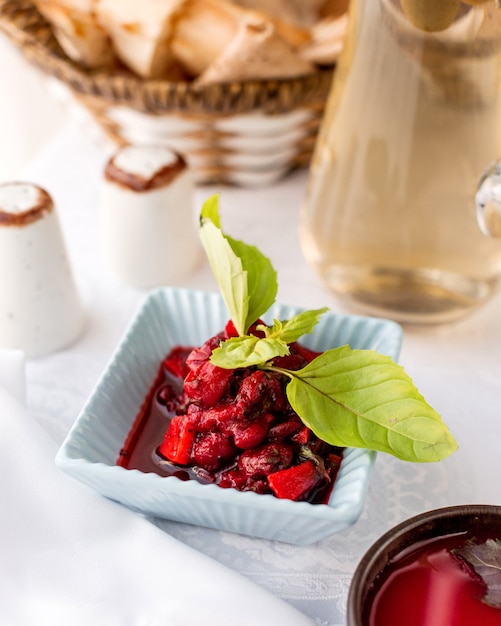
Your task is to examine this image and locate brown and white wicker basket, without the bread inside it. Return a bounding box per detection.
[0,0,332,186]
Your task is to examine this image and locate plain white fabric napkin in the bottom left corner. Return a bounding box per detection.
[0,351,312,626]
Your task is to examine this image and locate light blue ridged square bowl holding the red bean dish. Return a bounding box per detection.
[56,288,402,545]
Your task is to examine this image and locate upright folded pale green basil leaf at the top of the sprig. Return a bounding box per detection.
[200,195,278,335]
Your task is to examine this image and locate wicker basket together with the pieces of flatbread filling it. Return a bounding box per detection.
[0,0,347,186]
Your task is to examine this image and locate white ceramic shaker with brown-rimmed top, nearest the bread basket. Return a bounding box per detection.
[101,146,201,289]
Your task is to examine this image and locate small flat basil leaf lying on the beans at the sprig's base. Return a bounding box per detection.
[210,335,289,369]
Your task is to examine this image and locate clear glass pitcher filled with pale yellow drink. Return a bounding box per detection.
[300,0,501,323]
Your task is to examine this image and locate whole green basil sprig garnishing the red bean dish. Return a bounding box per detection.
[200,195,457,462]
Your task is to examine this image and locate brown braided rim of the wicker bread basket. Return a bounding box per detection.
[0,0,333,113]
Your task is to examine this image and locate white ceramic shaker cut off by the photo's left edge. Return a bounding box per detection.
[0,182,85,357]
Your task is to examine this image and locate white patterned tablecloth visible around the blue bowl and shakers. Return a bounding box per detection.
[3,118,494,626]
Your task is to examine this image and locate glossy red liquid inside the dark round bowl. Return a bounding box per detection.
[368,534,501,626]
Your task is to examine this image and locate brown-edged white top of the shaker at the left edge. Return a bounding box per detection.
[0,182,54,227]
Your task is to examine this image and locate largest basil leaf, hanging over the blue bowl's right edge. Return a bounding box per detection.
[287,346,457,462]
